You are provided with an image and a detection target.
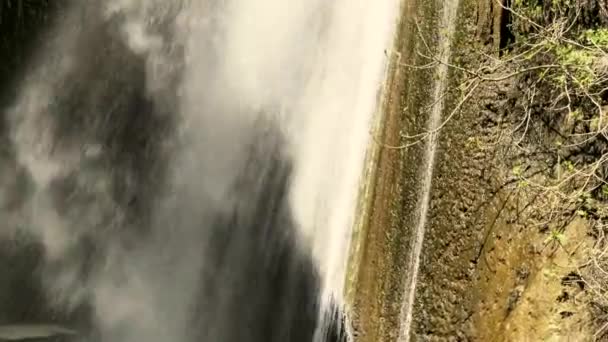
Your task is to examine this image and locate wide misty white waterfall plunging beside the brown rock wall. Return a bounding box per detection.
[0,0,399,342]
